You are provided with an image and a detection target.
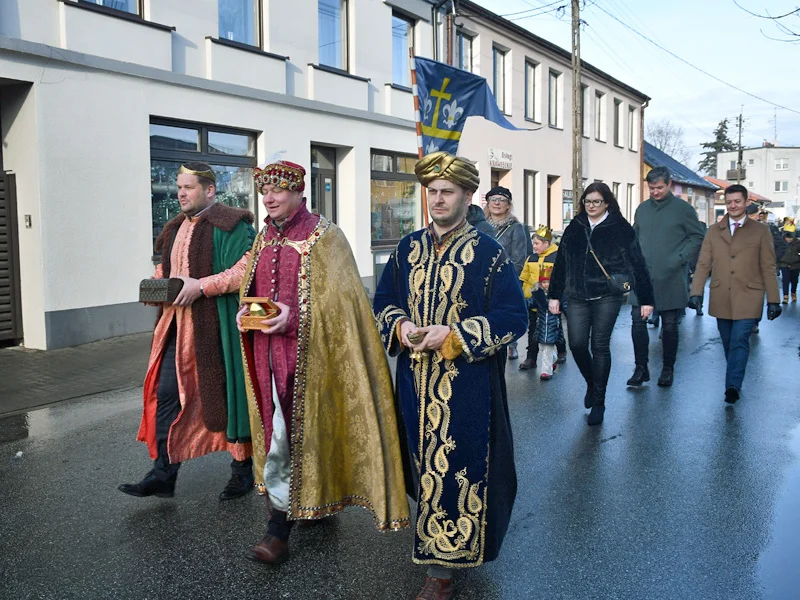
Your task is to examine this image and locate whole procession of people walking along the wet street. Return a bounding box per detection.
[119,152,788,600]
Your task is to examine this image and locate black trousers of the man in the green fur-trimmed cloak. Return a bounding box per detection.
[153,323,253,481]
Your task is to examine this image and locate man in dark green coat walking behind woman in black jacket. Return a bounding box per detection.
[628,167,706,387]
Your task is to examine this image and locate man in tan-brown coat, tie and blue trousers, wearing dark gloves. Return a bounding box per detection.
[689,185,781,404]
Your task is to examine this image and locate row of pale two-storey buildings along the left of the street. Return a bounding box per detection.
[0,0,647,349]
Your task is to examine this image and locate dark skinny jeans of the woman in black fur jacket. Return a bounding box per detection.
[567,297,622,405]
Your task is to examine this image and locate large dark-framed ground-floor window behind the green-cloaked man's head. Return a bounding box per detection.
[150,118,256,253]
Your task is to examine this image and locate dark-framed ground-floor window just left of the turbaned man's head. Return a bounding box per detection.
[370,151,420,246]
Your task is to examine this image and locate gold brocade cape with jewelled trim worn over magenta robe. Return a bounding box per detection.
[241,218,409,530]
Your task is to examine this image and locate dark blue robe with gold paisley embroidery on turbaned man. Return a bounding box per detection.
[373,224,528,567]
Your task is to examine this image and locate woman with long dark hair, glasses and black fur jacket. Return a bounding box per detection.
[550,183,653,425]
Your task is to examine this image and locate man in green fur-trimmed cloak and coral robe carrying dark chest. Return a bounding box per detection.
[119,163,255,500]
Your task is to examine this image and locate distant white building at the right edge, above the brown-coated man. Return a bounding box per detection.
[717,145,800,219]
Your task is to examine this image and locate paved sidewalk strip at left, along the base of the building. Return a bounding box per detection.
[0,333,152,415]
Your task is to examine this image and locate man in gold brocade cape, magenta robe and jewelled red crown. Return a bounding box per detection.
[237,161,409,564]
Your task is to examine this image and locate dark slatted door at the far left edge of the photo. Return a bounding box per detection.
[0,170,22,341]
